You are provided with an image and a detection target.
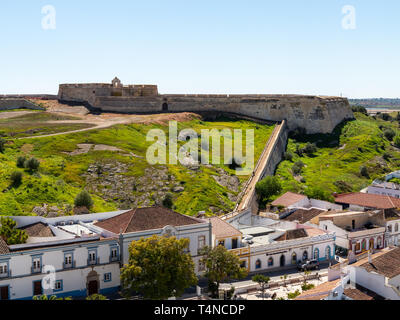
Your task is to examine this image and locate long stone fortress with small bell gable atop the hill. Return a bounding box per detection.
[58,78,354,134]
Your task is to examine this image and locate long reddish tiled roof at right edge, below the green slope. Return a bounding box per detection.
[335,192,400,209]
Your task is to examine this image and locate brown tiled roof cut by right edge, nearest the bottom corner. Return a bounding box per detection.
[354,248,400,279]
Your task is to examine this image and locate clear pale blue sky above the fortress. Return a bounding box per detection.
[0,0,400,98]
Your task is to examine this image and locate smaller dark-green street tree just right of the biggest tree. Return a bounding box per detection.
[200,246,247,297]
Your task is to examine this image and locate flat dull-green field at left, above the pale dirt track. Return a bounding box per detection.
[0,110,93,138]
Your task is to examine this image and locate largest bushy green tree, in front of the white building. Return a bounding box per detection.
[121,236,197,300]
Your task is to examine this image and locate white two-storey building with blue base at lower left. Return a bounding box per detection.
[0,212,125,300]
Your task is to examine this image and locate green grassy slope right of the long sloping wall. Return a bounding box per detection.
[276,113,400,199]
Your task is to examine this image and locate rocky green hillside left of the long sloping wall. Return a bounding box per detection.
[0,119,273,215]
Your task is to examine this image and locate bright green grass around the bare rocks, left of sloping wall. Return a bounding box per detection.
[0,114,273,215]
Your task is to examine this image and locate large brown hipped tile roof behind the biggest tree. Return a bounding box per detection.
[95,207,204,234]
